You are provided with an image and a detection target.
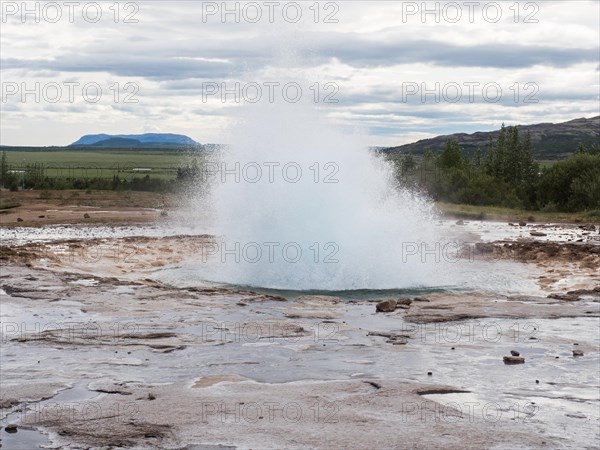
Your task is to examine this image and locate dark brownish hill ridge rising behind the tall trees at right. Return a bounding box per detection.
[380,116,600,159]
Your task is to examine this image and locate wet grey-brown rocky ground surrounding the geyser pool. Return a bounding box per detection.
[0,223,600,450]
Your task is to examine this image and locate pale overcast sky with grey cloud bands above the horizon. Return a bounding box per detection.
[0,0,600,146]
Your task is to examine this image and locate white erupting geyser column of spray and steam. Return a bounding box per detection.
[198,78,436,290]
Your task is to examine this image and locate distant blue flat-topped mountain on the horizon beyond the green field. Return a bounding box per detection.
[69,133,200,148]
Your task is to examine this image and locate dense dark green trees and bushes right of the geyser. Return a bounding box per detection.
[392,125,600,212]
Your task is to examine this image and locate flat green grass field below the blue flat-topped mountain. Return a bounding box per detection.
[6,150,198,179]
